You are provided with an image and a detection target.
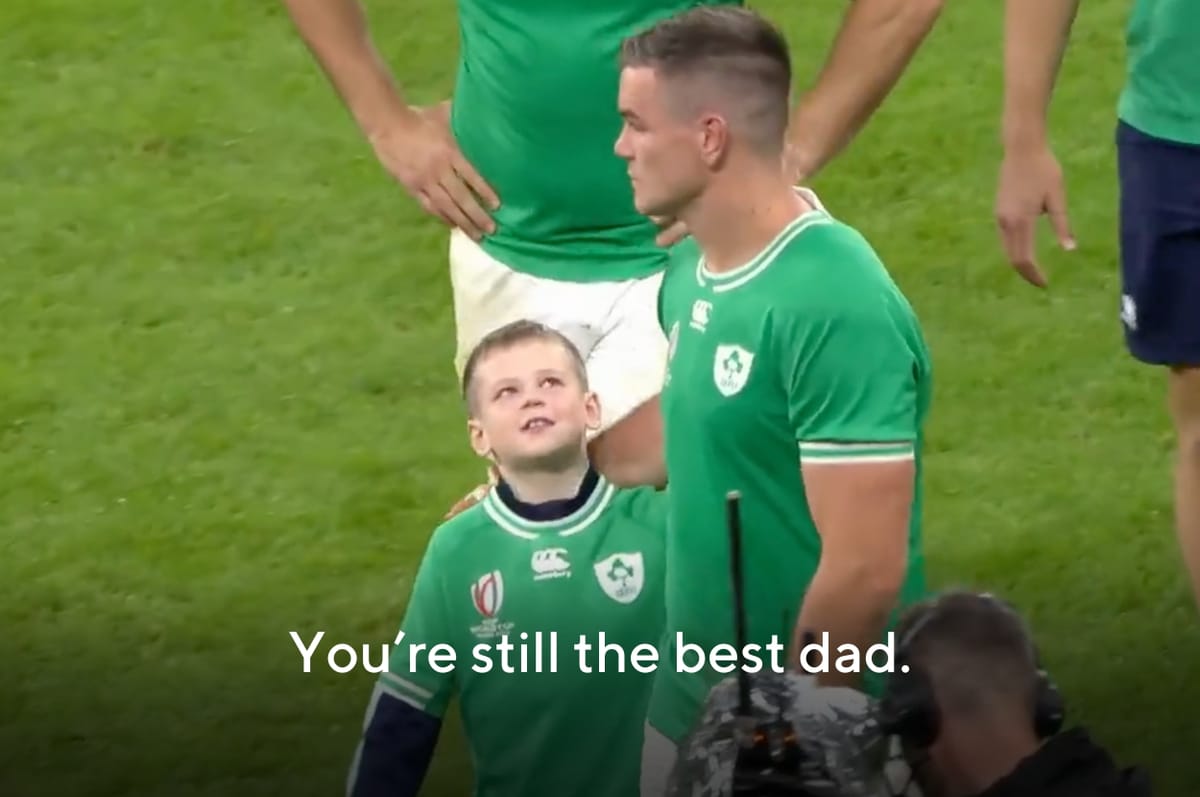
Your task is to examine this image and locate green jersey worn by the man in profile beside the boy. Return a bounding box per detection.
[649,195,931,739]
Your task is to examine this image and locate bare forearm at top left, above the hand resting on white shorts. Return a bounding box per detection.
[284,0,413,138]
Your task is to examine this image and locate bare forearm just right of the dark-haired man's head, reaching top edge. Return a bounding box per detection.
[785,0,943,182]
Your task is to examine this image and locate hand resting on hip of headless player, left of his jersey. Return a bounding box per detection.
[370,102,500,240]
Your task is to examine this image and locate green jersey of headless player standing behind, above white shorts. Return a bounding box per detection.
[451,0,740,282]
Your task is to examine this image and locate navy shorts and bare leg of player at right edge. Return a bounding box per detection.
[1117,118,1200,604]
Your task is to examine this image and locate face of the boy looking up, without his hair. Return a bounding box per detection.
[468,340,600,472]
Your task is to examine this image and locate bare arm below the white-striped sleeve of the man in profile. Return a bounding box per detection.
[791,457,916,688]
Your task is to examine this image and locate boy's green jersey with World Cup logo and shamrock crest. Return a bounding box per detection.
[362,477,666,797]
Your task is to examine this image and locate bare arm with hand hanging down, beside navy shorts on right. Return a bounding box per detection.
[996,0,1079,287]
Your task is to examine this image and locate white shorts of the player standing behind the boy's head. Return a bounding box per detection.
[450,229,667,436]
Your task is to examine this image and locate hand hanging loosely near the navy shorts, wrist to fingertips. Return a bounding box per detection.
[996,143,1075,288]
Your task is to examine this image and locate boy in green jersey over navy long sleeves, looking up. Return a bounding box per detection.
[348,322,666,797]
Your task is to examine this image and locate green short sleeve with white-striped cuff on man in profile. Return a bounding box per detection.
[775,300,920,462]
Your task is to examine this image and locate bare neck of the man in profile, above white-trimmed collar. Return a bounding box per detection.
[683,162,812,274]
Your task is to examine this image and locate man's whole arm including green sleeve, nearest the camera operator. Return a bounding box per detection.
[774,289,924,687]
